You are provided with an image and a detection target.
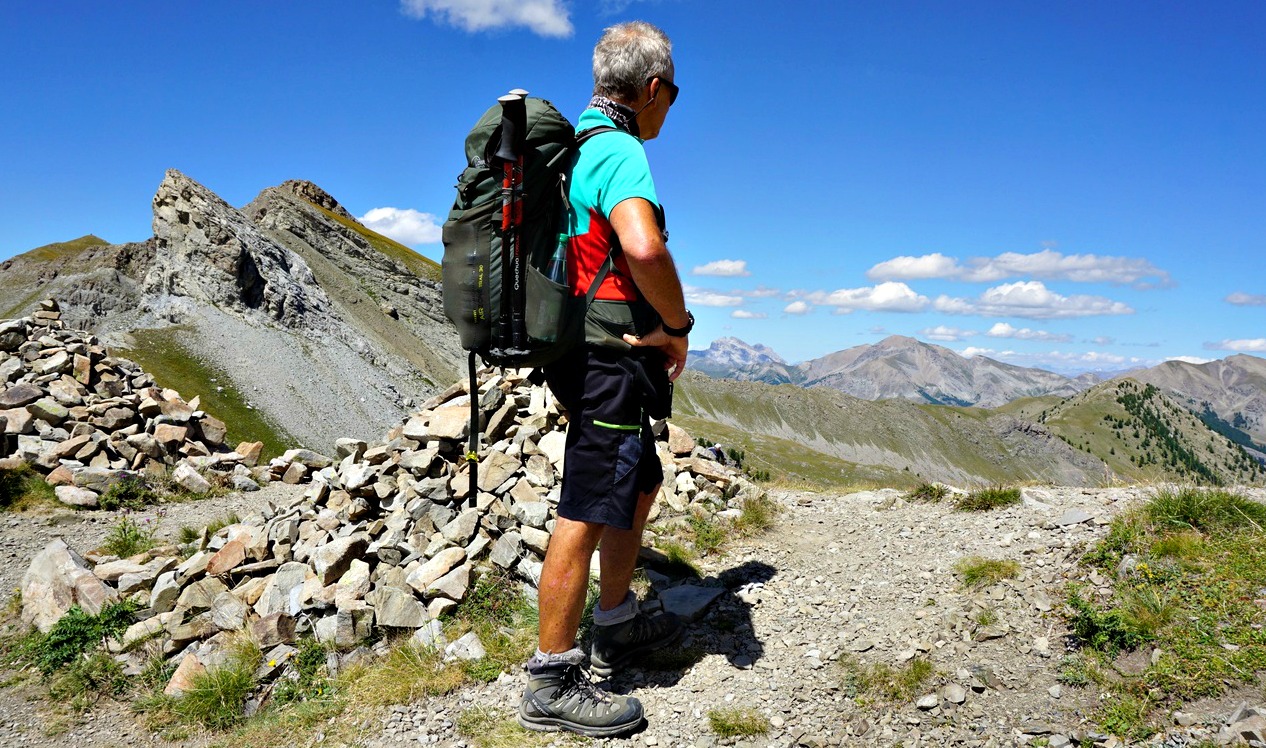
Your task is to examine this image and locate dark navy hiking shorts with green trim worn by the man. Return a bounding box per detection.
[546,346,666,530]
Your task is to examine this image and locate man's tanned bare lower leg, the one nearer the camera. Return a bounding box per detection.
[538,516,605,654]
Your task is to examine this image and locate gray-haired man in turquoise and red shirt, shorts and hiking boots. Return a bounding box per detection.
[519,22,694,737]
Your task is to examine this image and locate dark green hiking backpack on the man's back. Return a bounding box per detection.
[442,92,615,368]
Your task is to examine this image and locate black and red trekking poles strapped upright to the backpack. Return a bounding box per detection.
[496,94,528,349]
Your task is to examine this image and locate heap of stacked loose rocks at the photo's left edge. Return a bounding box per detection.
[0,299,266,506]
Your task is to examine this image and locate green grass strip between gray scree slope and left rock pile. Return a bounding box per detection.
[119,327,295,461]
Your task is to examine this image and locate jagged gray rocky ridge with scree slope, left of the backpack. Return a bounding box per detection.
[0,170,461,452]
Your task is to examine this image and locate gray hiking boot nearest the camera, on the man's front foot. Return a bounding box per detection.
[519,649,642,738]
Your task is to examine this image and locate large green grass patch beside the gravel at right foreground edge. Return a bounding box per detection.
[1066,489,1266,740]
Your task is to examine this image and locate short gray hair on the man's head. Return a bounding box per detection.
[594,20,672,104]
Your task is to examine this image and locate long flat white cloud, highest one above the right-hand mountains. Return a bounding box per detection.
[866,249,1172,289]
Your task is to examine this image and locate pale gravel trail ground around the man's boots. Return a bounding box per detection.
[0,489,1266,748]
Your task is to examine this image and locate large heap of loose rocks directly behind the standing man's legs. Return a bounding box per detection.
[23,359,760,690]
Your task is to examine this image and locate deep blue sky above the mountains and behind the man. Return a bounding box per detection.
[0,0,1266,372]
